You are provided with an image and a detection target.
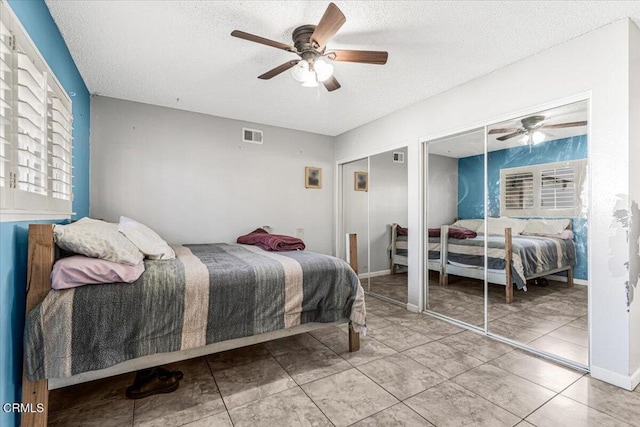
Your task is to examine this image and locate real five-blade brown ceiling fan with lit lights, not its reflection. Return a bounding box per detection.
[231,3,388,92]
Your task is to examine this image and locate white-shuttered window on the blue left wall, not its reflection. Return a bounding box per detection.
[0,2,73,221]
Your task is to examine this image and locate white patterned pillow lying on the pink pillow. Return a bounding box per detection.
[53,218,143,265]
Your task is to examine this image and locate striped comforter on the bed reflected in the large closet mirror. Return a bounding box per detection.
[429,235,576,289]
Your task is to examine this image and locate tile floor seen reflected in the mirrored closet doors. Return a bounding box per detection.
[365,273,589,366]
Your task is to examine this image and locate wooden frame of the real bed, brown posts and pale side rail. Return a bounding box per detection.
[21,224,360,427]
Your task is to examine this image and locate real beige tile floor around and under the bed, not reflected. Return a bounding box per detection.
[49,297,640,427]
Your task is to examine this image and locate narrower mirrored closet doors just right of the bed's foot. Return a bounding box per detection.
[340,147,409,305]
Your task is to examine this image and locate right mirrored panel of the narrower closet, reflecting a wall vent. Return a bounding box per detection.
[369,147,409,304]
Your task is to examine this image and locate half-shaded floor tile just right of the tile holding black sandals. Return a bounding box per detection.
[214,358,296,410]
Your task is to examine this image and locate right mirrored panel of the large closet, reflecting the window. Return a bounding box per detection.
[487,101,588,366]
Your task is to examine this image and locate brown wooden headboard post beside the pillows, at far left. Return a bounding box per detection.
[21,224,55,427]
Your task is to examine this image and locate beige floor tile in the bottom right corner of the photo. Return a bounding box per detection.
[562,376,640,426]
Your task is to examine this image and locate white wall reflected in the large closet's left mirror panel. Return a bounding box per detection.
[426,154,458,228]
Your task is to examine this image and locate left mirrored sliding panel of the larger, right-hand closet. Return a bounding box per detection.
[425,129,485,329]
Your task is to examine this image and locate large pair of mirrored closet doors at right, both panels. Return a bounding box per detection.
[425,101,589,367]
